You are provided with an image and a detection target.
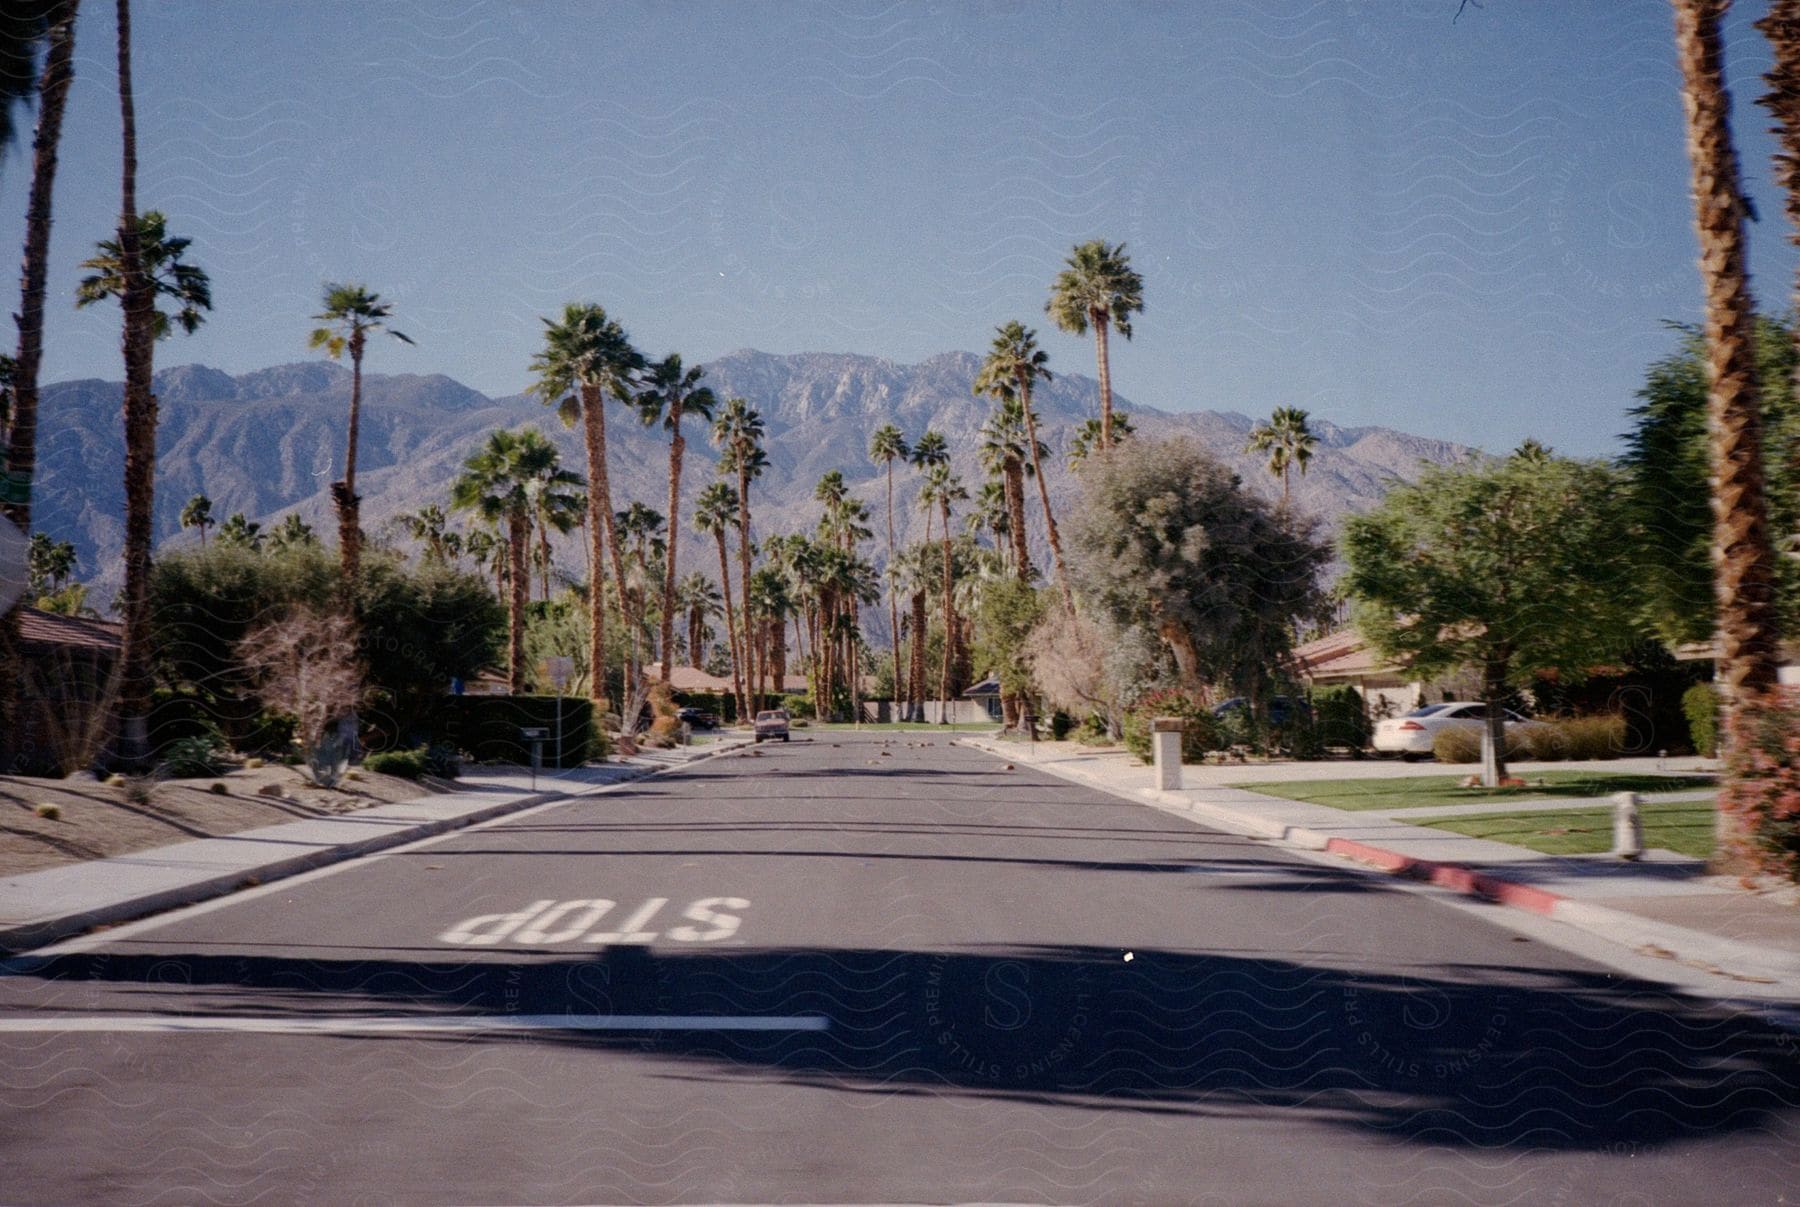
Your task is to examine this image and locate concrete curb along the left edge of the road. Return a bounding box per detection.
[0,739,749,959]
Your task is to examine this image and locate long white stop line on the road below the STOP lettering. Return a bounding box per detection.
[0,1015,830,1034]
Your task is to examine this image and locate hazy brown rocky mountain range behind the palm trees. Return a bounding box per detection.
[24,351,1472,599]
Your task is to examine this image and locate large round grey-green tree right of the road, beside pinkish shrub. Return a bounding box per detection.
[1069,437,1330,698]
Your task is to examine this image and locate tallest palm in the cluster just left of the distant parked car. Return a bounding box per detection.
[531,302,644,709]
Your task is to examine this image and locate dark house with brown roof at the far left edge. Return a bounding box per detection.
[0,608,124,773]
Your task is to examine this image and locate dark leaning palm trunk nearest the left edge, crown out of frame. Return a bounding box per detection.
[0,0,76,770]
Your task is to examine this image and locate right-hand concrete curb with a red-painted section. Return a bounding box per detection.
[961,738,1800,984]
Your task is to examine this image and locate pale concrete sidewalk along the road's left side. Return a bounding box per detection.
[0,736,751,957]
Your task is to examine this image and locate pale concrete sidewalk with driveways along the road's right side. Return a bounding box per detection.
[958,736,1800,1000]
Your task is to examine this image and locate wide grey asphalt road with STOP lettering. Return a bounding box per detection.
[0,736,1800,1203]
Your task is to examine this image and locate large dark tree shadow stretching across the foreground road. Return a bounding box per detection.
[0,946,1800,1160]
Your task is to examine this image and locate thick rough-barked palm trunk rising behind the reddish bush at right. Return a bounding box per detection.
[1674,0,1780,863]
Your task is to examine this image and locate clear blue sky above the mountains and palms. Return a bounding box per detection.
[0,0,1795,455]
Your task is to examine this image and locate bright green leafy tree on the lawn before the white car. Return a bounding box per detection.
[1341,446,1638,777]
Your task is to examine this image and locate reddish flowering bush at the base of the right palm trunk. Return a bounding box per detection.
[1719,689,1800,880]
